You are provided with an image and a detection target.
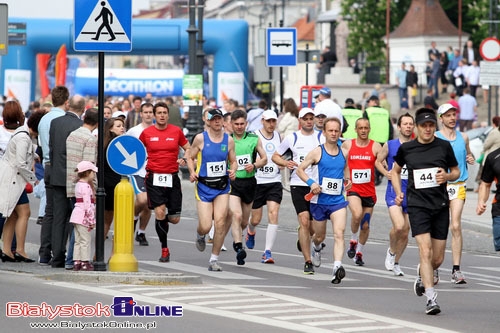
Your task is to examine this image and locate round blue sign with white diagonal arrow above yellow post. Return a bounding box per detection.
[106,135,146,176]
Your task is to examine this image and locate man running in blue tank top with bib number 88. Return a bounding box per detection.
[297,118,351,284]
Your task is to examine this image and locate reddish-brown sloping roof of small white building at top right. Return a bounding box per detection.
[390,0,458,38]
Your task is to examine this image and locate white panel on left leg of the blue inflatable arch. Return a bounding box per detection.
[3,69,31,112]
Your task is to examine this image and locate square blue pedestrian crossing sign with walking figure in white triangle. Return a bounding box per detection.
[73,0,132,52]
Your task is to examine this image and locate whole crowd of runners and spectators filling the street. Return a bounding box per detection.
[0,77,500,314]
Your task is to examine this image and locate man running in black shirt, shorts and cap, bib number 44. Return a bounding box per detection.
[391,108,460,315]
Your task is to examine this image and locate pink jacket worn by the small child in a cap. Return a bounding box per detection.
[69,181,95,227]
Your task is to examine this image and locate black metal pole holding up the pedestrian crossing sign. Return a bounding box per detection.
[94,52,106,271]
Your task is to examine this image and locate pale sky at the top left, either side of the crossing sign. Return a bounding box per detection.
[0,0,149,19]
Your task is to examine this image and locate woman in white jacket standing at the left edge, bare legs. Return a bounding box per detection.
[0,106,43,262]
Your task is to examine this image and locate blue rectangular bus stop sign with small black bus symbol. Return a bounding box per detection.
[266,28,297,67]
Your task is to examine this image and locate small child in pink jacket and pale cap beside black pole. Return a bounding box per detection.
[69,161,97,271]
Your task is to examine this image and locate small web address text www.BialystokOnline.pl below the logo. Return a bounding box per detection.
[30,320,157,330]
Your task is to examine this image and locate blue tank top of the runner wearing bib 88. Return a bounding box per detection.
[311,145,347,205]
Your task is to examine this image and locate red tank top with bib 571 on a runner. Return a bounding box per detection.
[347,139,377,199]
